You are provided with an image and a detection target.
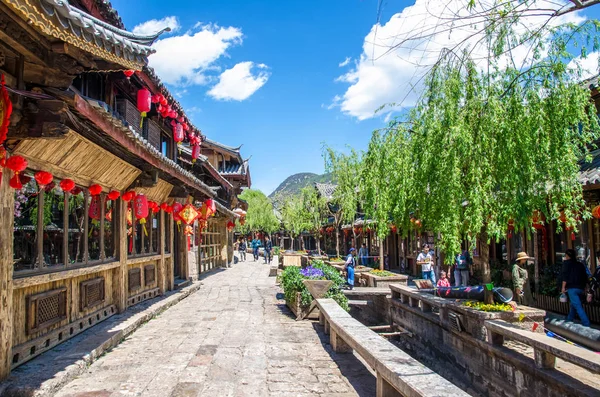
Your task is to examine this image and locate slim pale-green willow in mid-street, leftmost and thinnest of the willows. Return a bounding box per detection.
[323,146,363,257]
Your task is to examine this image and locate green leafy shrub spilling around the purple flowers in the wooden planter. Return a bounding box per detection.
[279,260,350,311]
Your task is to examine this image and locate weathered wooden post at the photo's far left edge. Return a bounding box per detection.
[0,169,15,380]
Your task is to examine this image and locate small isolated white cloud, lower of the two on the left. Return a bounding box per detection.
[208,62,270,101]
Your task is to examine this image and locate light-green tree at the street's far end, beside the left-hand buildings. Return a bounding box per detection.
[237,189,280,234]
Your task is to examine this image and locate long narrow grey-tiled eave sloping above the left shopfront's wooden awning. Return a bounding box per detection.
[87,99,215,197]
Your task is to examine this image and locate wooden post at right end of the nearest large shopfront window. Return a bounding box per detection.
[113,200,133,313]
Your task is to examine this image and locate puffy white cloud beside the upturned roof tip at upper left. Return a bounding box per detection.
[149,23,242,85]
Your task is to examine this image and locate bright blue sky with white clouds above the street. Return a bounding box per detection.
[112,0,600,194]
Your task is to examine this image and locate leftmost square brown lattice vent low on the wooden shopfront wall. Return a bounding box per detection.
[26,287,67,334]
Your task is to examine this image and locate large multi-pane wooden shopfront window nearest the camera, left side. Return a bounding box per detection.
[13,175,117,275]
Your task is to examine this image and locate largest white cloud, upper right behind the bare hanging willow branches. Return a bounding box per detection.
[331,0,584,120]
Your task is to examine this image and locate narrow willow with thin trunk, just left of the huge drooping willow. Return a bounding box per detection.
[360,126,414,270]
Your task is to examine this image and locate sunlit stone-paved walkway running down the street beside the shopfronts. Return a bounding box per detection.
[57,261,375,397]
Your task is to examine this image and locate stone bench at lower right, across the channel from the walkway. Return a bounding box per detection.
[485,320,600,374]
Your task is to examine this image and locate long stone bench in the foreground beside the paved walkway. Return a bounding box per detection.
[316,299,469,397]
